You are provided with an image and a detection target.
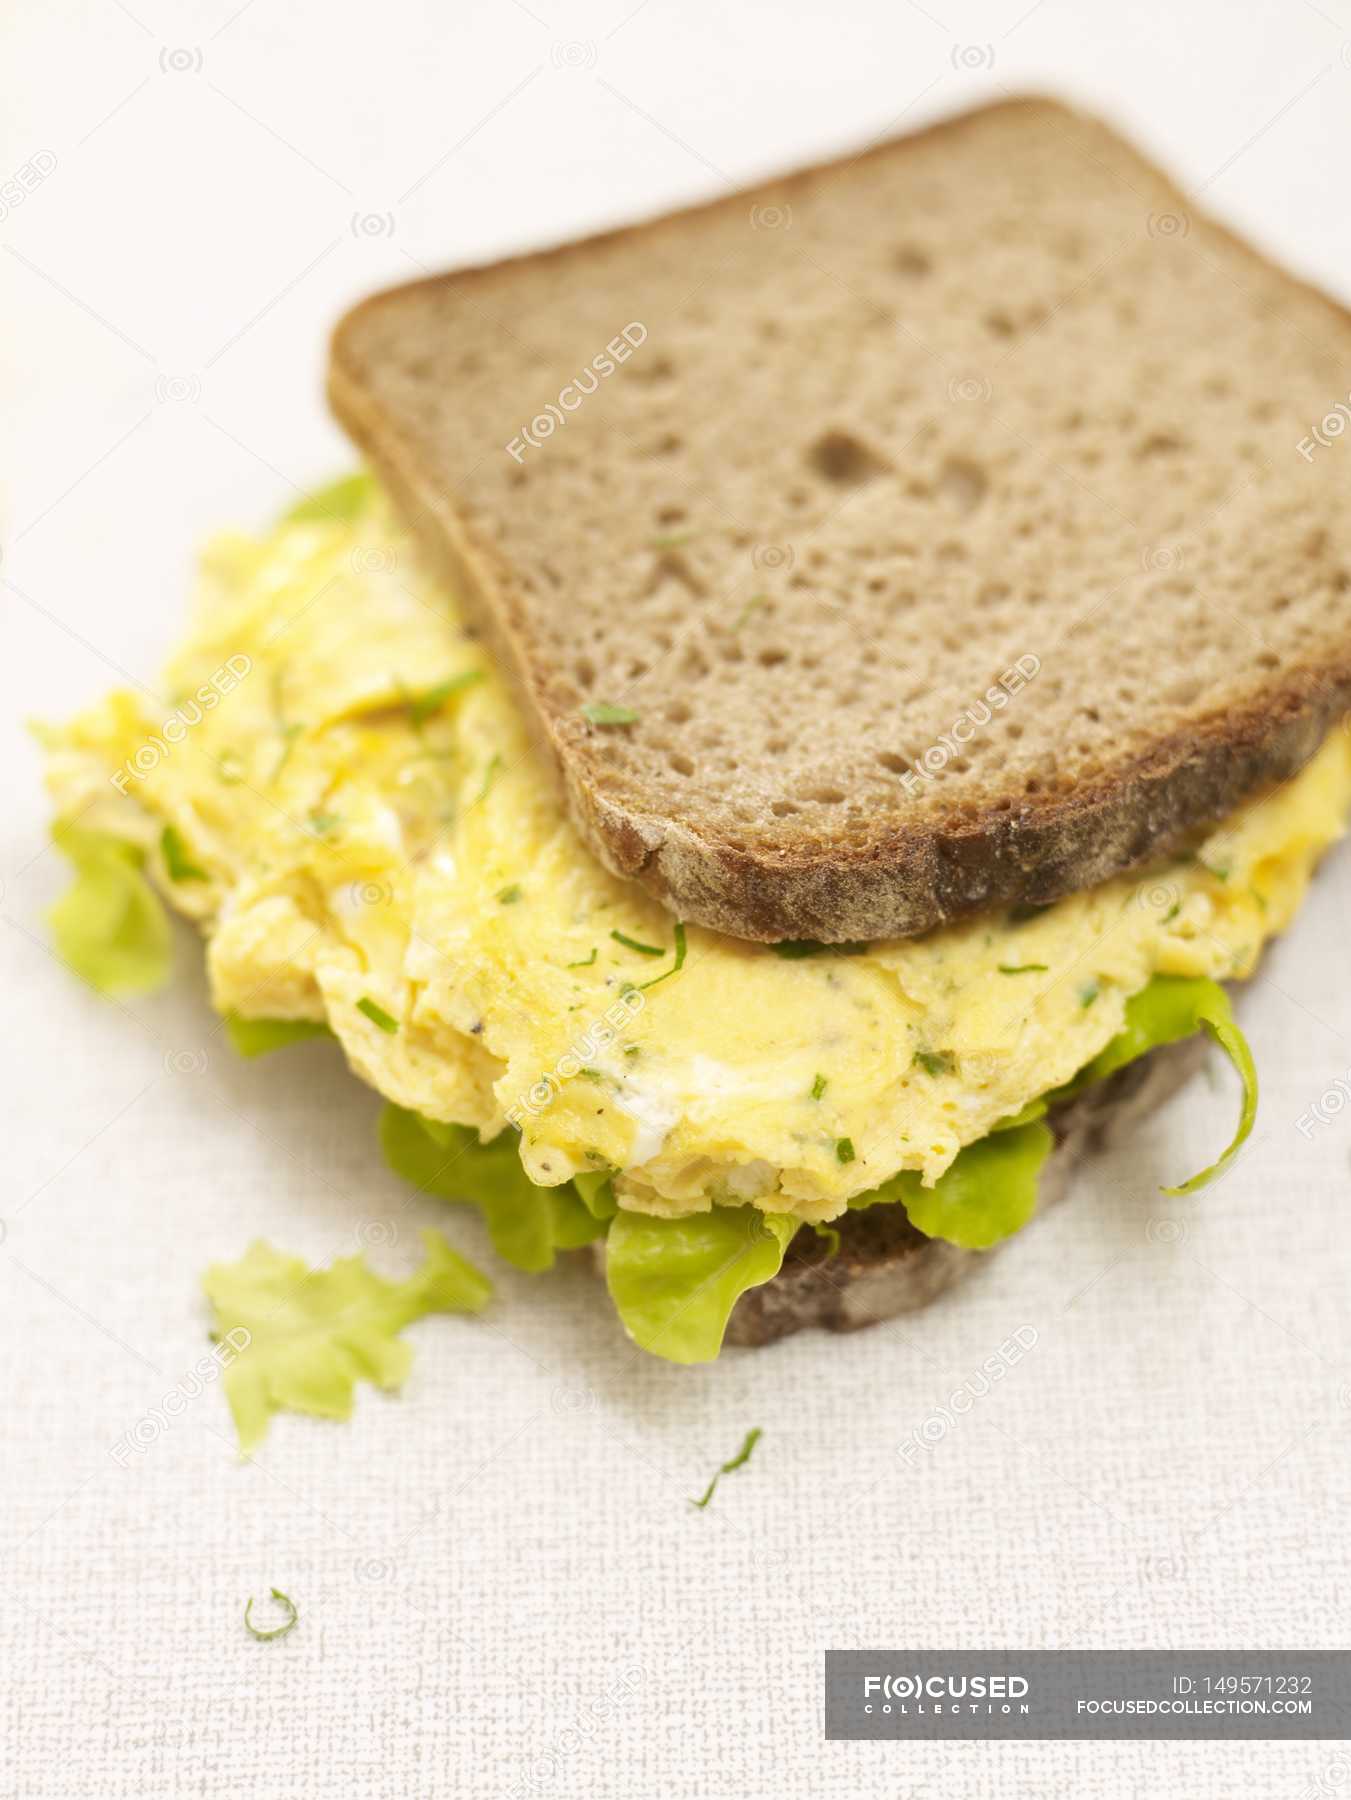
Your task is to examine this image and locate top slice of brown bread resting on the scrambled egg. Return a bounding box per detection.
[331,99,1351,941]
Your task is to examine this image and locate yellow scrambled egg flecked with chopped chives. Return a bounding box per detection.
[50,500,1351,1219]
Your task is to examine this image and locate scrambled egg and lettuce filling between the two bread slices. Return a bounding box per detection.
[45,477,1351,1361]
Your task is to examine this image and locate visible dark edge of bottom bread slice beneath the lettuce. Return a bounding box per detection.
[725,1035,1207,1345]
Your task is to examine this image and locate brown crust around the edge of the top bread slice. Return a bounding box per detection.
[329,97,1351,943]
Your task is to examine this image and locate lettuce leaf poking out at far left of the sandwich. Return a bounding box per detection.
[47,819,173,995]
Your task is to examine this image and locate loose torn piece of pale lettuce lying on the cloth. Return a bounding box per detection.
[201,1231,493,1456]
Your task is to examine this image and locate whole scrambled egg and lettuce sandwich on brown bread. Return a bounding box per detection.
[47,101,1351,1363]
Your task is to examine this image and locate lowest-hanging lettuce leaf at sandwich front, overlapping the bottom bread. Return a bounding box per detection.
[604,1206,799,1363]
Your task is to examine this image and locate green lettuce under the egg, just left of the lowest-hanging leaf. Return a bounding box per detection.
[380,1103,608,1274]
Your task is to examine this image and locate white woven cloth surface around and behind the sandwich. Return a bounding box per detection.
[0,0,1351,1800]
